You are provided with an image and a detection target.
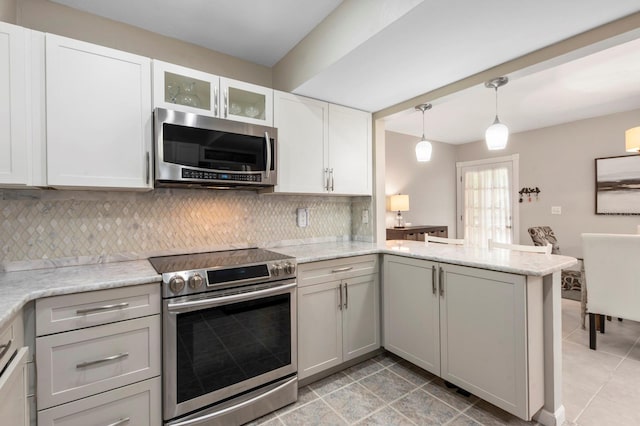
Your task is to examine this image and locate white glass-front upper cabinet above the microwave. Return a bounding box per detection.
[153,60,273,126]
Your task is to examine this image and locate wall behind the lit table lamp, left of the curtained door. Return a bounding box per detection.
[385,132,456,237]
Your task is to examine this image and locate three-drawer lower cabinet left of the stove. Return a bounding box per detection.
[35,284,162,426]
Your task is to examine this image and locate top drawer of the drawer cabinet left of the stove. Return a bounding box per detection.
[36,284,160,336]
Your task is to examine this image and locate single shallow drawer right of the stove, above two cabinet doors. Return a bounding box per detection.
[298,254,378,287]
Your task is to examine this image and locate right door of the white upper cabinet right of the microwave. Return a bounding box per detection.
[329,104,373,195]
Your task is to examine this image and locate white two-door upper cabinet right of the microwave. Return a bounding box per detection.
[273,91,373,195]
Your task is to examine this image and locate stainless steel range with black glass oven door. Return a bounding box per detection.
[149,248,298,426]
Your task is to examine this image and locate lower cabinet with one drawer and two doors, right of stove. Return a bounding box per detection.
[298,255,380,379]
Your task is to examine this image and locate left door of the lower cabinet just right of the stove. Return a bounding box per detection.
[298,281,342,379]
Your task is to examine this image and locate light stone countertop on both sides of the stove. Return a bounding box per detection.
[0,240,577,328]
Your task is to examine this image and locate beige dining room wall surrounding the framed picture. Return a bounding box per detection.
[456,110,640,257]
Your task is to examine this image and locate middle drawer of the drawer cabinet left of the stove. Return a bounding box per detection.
[36,315,161,409]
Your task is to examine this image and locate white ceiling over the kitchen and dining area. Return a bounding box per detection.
[53,0,640,143]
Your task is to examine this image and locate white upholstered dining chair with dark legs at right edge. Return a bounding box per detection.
[582,234,640,350]
